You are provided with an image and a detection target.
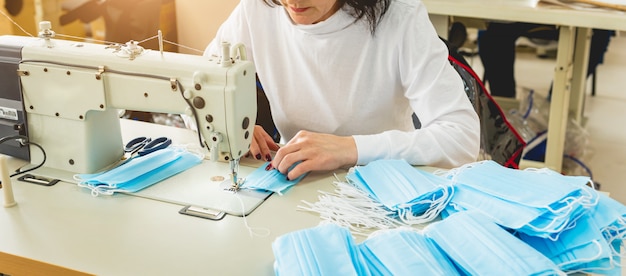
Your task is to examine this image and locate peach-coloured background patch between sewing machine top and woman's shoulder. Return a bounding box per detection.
[176,0,239,54]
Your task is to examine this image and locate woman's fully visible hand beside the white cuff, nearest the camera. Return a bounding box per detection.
[268,131,357,180]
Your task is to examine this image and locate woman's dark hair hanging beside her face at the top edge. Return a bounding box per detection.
[263,0,392,35]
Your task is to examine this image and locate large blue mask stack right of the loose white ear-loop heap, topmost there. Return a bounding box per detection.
[436,161,598,239]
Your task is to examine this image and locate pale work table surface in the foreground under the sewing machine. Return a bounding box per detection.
[0,121,345,275]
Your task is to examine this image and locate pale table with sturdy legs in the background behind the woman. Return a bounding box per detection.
[423,0,626,171]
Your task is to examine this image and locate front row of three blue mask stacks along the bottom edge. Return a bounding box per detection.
[272,212,565,275]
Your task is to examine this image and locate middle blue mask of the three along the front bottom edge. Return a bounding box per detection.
[358,229,458,275]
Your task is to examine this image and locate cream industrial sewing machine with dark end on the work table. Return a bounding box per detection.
[0,22,256,188]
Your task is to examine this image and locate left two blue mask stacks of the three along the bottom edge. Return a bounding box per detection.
[272,223,458,276]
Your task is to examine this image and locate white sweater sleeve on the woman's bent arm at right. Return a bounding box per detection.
[353,3,480,168]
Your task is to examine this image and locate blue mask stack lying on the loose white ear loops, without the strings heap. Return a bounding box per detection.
[346,160,453,224]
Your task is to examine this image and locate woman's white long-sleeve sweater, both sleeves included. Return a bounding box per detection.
[205,0,480,168]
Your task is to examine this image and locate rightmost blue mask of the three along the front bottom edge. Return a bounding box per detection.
[424,211,565,275]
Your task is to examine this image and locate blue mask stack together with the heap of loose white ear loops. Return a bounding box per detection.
[298,160,453,234]
